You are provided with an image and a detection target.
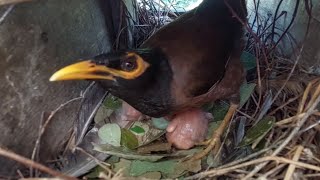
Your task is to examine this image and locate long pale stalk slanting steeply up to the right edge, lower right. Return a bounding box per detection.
[243,85,320,180]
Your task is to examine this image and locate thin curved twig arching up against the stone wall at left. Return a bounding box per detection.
[30,96,83,175]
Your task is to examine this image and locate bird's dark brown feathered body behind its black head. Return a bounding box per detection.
[141,0,246,112]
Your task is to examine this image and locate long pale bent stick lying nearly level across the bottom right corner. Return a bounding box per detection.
[186,156,320,180]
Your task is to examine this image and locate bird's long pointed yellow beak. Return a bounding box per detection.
[50,60,114,81]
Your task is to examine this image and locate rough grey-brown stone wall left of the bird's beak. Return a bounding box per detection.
[0,0,110,175]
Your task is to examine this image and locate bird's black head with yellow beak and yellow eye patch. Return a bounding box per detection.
[50,49,168,90]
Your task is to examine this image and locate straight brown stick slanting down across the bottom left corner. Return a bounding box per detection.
[0,147,77,180]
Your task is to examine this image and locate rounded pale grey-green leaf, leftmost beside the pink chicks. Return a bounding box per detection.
[98,124,121,146]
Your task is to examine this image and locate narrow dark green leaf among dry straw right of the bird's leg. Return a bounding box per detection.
[239,116,275,147]
